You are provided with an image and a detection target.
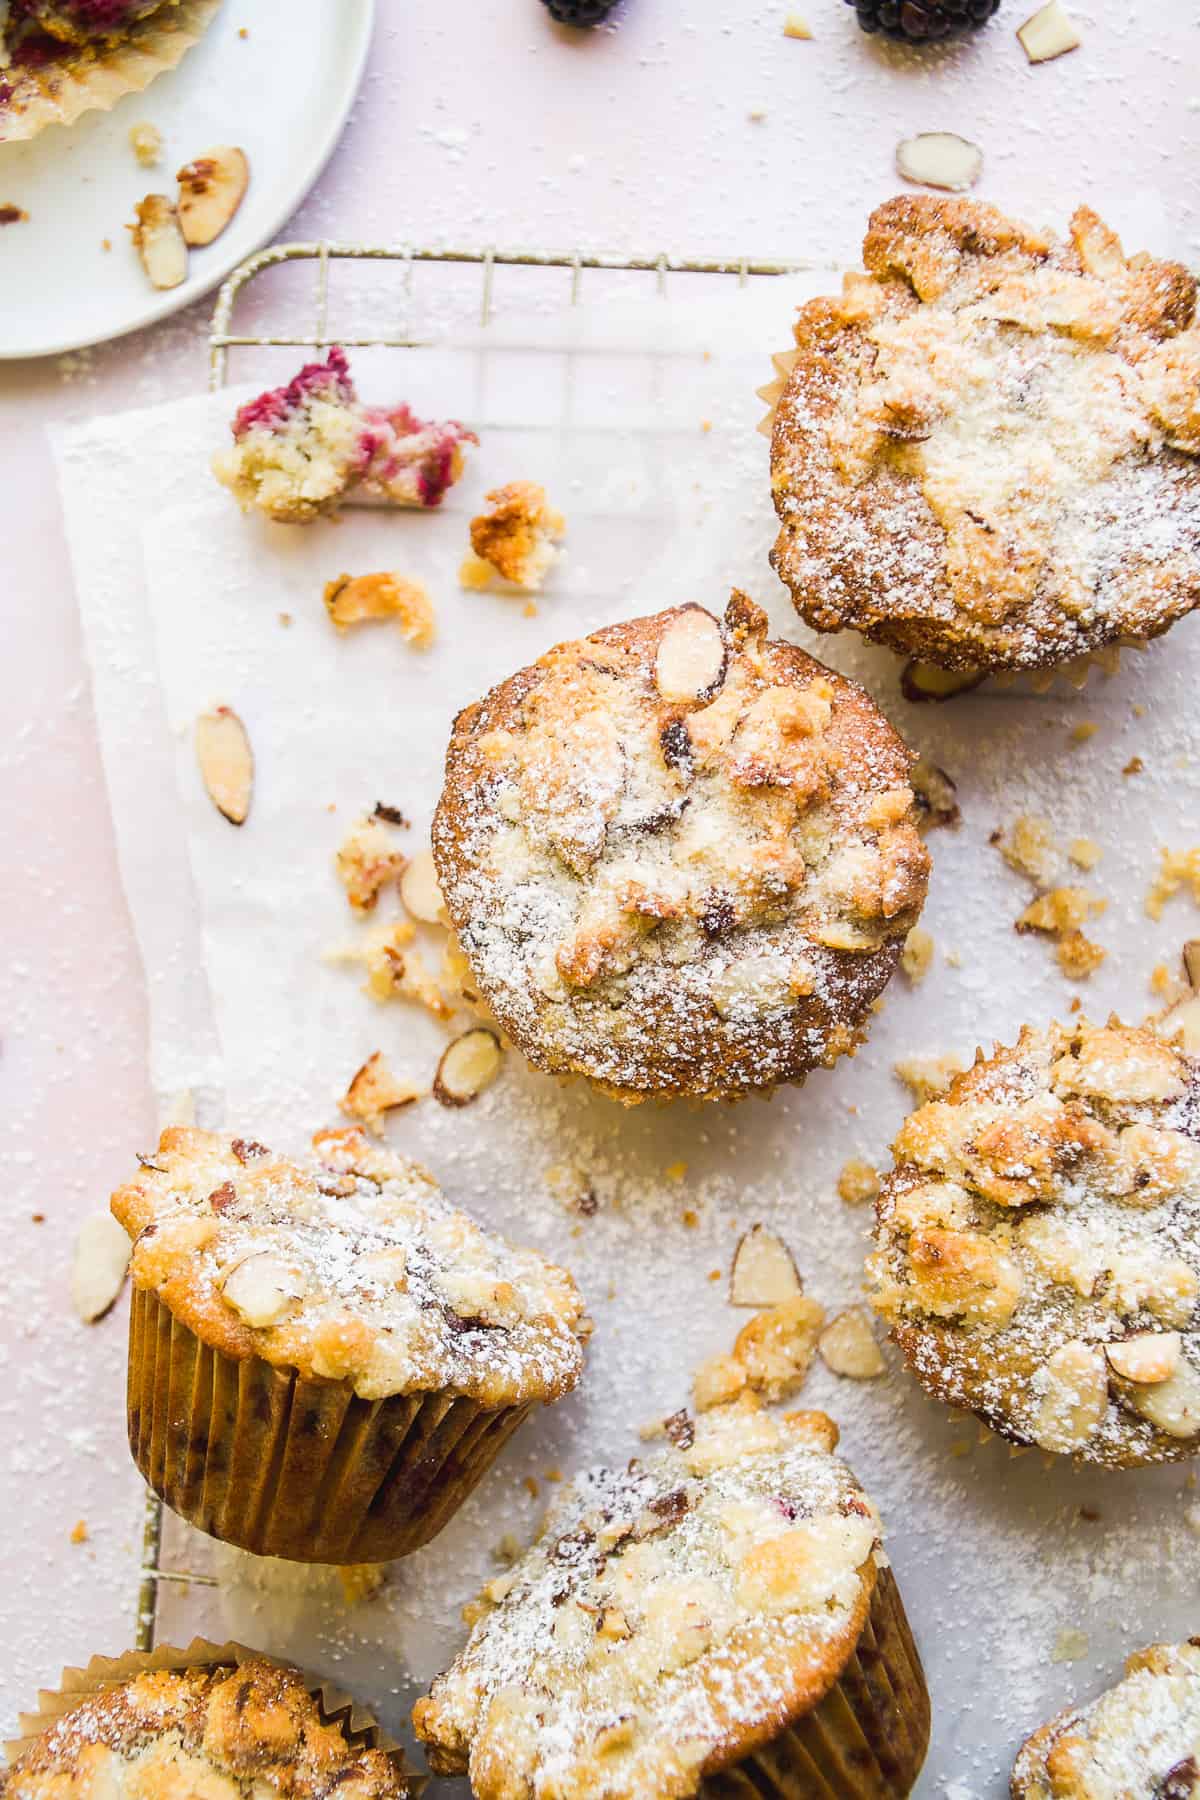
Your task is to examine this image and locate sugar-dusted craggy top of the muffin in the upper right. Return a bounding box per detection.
[772,194,1200,670]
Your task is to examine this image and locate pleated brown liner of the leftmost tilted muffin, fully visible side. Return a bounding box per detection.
[128,1289,531,1562]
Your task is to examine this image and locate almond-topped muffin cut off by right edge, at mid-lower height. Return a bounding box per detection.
[869,1021,1200,1469]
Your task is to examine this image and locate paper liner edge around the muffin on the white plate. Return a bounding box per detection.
[0,0,221,144]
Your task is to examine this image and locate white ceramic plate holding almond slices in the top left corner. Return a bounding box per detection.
[0,0,374,356]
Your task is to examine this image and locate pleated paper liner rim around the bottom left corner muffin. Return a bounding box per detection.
[4,1638,426,1796]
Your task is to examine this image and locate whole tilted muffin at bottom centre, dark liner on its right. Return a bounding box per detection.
[414,1402,930,1800]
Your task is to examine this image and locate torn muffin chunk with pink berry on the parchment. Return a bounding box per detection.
[212,344,479,524]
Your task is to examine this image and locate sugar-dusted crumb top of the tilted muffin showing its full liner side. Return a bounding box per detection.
[112,1129,590,1406]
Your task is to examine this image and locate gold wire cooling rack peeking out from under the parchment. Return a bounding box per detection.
[135,243,813,1651]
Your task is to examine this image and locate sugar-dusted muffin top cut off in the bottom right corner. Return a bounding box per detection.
[1013,1638,1200,1800]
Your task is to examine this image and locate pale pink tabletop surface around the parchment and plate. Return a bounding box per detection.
[0,0,1200,1728]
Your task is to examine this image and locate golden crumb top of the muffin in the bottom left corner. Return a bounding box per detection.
[0,1660,408,1800]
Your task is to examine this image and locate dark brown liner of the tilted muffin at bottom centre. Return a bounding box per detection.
[696,1568,930,1800]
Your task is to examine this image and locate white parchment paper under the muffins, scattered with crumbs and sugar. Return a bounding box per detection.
[58,277,1200,1800]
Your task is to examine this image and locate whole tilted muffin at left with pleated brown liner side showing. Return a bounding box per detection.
[112,1129,590,1562]
